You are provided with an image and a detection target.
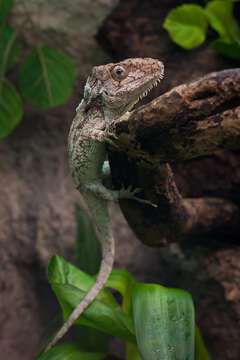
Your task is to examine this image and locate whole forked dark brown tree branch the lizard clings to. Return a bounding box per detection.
[109,69,240,245]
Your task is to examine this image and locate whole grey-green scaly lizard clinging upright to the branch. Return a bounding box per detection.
[45,58,164,351]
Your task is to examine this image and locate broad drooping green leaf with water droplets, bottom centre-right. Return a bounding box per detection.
[133,284,194,360]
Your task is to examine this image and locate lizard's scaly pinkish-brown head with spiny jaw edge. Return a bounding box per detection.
[84,58,164,122]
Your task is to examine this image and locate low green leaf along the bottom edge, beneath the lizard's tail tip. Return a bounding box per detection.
[35,342,107,360]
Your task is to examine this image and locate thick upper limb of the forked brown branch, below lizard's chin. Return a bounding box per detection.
[112,69,240,166]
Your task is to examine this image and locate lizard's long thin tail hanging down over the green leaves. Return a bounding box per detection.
[45,194,115,352]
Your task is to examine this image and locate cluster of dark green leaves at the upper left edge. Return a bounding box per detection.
[0,0,76,139]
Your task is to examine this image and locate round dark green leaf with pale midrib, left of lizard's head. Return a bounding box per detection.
[19,46,76,109]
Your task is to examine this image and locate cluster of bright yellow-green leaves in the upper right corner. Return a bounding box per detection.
[163,0,240,60]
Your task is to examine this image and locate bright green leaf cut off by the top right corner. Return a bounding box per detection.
[205,0,240,43]
